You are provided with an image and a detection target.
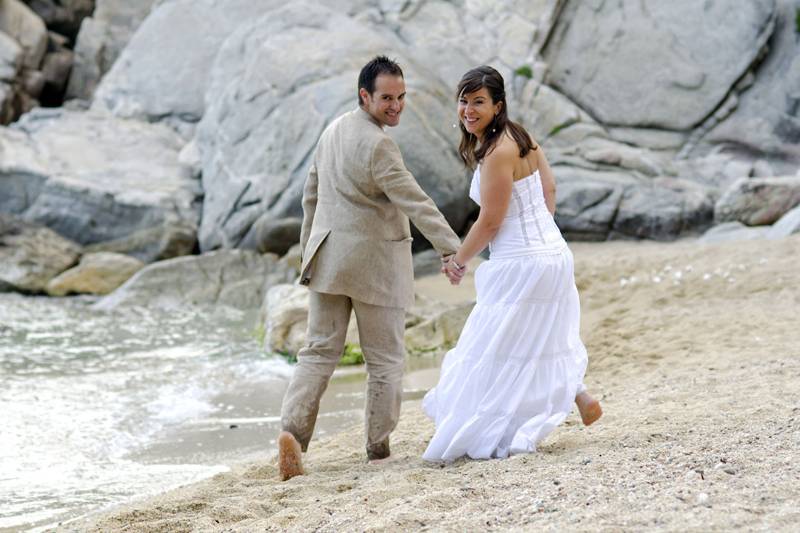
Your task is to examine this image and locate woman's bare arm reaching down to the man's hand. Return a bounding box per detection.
[454,143,519,265]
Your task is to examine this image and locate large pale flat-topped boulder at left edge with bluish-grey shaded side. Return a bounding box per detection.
[0,109,201,261]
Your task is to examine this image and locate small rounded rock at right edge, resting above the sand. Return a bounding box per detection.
[714,176,800,226]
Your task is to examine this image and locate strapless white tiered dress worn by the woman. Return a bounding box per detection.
[423,168,587,461]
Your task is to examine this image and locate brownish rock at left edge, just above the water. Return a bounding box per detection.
[0,213,81,293]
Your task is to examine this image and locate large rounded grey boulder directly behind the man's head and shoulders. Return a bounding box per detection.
[197,3,469,250]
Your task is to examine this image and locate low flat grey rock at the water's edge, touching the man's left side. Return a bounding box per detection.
[95,250,294,309]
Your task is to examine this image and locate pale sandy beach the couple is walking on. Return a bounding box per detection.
[67,235,800,532]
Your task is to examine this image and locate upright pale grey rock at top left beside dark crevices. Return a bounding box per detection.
[67,0,155,100]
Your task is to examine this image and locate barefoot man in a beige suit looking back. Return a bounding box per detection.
[278,56,460,480]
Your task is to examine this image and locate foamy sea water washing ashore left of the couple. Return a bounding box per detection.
[0,294,394,531]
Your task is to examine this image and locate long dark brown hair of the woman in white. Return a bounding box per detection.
[456,65,537,168]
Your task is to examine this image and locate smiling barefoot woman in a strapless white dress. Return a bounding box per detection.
[423,66,602,461]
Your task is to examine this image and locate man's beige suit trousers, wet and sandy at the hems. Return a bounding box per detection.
[281,291,405,458]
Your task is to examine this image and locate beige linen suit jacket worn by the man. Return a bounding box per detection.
[300,108,461,307]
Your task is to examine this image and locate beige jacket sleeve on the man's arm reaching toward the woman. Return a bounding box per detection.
[371,137,461,255]
